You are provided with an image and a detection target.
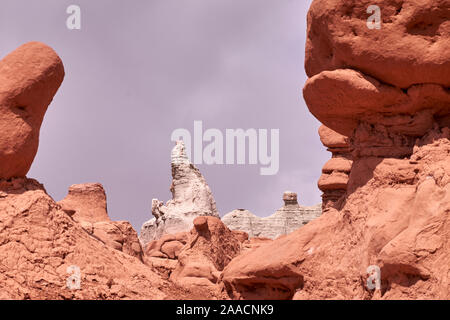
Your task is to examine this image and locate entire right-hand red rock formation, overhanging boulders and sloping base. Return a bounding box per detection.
[221,0,450,299]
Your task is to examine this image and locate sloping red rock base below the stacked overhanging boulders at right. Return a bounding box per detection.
[222,130,450,299]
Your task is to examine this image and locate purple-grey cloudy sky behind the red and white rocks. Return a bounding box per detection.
[0,0,330,231]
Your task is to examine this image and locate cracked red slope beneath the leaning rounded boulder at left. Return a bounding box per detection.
[0,178,172,299]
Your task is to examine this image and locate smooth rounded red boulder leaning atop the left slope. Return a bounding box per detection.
[0,42,64,179]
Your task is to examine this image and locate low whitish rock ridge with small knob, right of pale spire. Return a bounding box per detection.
[222,191,322,239]
